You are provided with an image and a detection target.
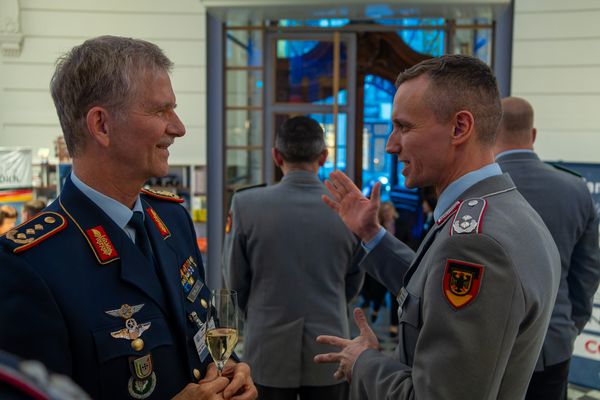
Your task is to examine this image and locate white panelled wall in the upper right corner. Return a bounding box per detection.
[512,0,600,163]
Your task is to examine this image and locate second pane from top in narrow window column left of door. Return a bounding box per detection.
[226,70,263,107]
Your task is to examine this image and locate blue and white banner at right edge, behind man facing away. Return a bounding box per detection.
[552,162,600,389]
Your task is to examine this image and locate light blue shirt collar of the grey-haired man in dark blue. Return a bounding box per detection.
[71,171,144,242]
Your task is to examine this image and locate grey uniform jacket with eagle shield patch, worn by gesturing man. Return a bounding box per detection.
[350,174,560,400]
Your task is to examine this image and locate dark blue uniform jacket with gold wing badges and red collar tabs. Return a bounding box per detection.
[0,179,210,400]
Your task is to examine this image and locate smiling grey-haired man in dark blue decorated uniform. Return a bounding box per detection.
[0,36,256,399]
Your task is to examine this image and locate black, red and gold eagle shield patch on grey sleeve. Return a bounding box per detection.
[443,260,483,310]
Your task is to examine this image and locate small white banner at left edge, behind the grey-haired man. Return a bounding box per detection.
[0,147,32,190]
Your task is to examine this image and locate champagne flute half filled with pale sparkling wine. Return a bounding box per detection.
[206,289,238,376]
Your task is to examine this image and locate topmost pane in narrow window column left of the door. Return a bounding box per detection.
[225,29,262,67]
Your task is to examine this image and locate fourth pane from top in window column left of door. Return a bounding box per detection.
[225,149,263,186]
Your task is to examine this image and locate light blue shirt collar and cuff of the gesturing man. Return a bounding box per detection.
[362,163,502,253]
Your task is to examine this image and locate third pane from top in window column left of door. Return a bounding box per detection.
[225,110,263,147]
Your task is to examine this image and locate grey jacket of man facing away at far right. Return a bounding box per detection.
[497,153,600,370]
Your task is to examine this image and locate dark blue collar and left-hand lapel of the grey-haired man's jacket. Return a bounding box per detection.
[59,178,166,311]
